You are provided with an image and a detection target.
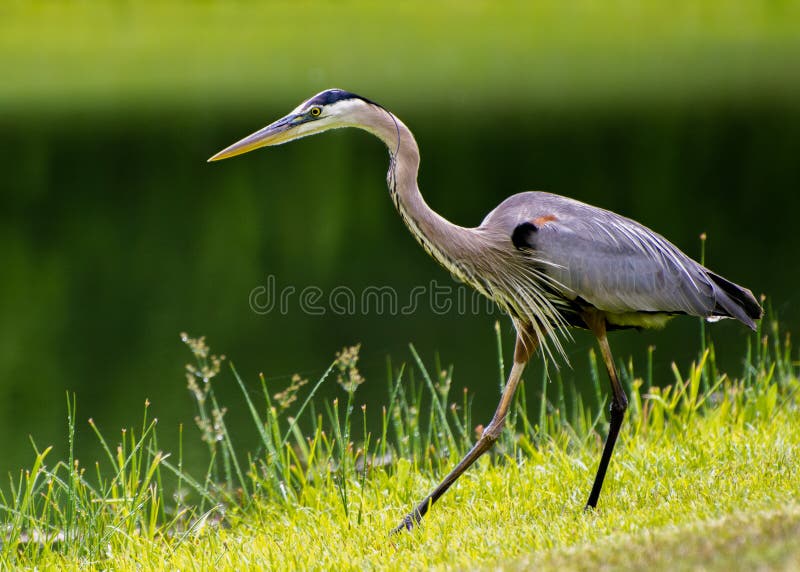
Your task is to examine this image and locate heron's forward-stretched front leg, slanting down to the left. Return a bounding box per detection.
[392,337,538,534]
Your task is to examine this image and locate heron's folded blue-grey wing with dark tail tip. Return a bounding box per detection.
[484,193,761,327]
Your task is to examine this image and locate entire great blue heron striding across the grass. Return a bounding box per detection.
[209,89,763,531]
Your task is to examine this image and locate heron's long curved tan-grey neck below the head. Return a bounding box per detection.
[365,106,480,283]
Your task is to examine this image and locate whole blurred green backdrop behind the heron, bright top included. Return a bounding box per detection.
[0,0,800,474]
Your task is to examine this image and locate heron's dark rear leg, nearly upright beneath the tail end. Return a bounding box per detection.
[584,313,628,510]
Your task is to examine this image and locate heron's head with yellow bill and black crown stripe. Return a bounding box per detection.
[209,89,379,161]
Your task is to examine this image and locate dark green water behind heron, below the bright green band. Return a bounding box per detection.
[0,105,800,474]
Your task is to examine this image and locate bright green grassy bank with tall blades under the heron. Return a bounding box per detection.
[0,323,800,570]
